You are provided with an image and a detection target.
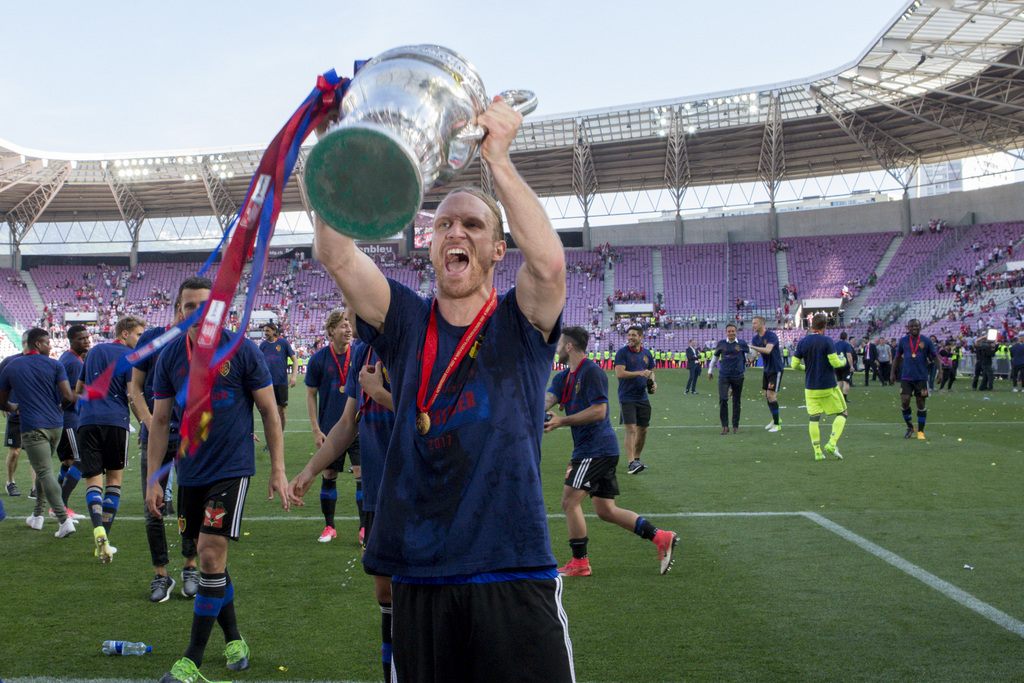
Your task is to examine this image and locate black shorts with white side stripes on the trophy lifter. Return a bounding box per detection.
[391,579,575,683]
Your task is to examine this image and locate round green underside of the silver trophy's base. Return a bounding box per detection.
[306,125,423,240]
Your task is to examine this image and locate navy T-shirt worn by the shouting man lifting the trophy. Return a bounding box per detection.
[357,280,561,580]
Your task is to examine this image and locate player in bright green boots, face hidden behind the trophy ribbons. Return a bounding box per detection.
[145,281,290,683]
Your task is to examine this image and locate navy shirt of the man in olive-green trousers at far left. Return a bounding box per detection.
[0,351,68,432]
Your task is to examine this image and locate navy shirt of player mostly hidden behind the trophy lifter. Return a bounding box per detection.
[345,344,394,509]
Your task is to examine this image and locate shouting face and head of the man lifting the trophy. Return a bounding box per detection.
[430,193,505,299]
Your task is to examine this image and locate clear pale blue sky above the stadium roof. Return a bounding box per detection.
[6,0,906,154]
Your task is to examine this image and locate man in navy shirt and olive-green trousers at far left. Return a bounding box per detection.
[0,328,77,539]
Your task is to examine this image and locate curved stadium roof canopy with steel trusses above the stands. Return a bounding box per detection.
[6,0,1024,246]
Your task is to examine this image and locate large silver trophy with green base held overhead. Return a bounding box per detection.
[305,45,537,240]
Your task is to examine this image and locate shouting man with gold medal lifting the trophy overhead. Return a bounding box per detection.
[315,100,573,683]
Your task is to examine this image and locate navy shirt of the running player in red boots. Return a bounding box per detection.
[548,358,618,460]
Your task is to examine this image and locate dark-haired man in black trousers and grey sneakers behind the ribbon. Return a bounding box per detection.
[130,288,198,602]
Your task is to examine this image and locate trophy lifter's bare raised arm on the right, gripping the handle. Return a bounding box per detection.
[479,97,565,337]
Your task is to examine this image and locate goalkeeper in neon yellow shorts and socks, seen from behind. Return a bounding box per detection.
[793,313,847,460]
